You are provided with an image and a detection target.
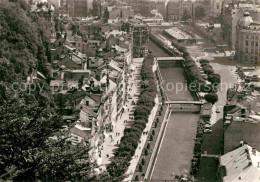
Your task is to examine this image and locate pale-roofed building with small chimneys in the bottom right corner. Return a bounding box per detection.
[218,142,260,182]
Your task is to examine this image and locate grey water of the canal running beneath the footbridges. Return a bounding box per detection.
[149,38,199,181]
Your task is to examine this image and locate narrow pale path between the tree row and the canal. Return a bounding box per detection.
[124,95,160,182]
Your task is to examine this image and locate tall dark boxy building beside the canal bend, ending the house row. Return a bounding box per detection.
[132,24,149,58]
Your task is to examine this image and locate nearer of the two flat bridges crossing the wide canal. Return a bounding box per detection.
[165,101,203,112]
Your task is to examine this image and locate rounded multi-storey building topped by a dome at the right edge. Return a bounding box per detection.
[235,12,260,64]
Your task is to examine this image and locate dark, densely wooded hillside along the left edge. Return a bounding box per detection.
[0,1,94,181]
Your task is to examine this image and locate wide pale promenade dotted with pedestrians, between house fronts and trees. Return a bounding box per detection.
[100,61,142,171]
